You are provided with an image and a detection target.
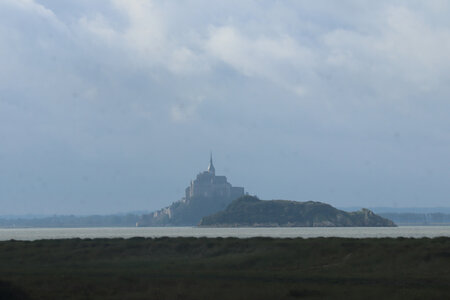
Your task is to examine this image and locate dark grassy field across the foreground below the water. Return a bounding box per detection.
[0,238,450,299]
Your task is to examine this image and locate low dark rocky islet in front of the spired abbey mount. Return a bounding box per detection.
[200,195,396,227]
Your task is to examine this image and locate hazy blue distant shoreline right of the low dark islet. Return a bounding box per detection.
[378,213,450,225]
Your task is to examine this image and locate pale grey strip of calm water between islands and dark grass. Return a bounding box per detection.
[0,226,450,241]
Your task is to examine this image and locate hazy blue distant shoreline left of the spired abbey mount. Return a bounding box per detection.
[0,214,140,227]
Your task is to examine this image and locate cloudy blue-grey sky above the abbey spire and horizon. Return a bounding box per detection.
[0,0,450,215]
